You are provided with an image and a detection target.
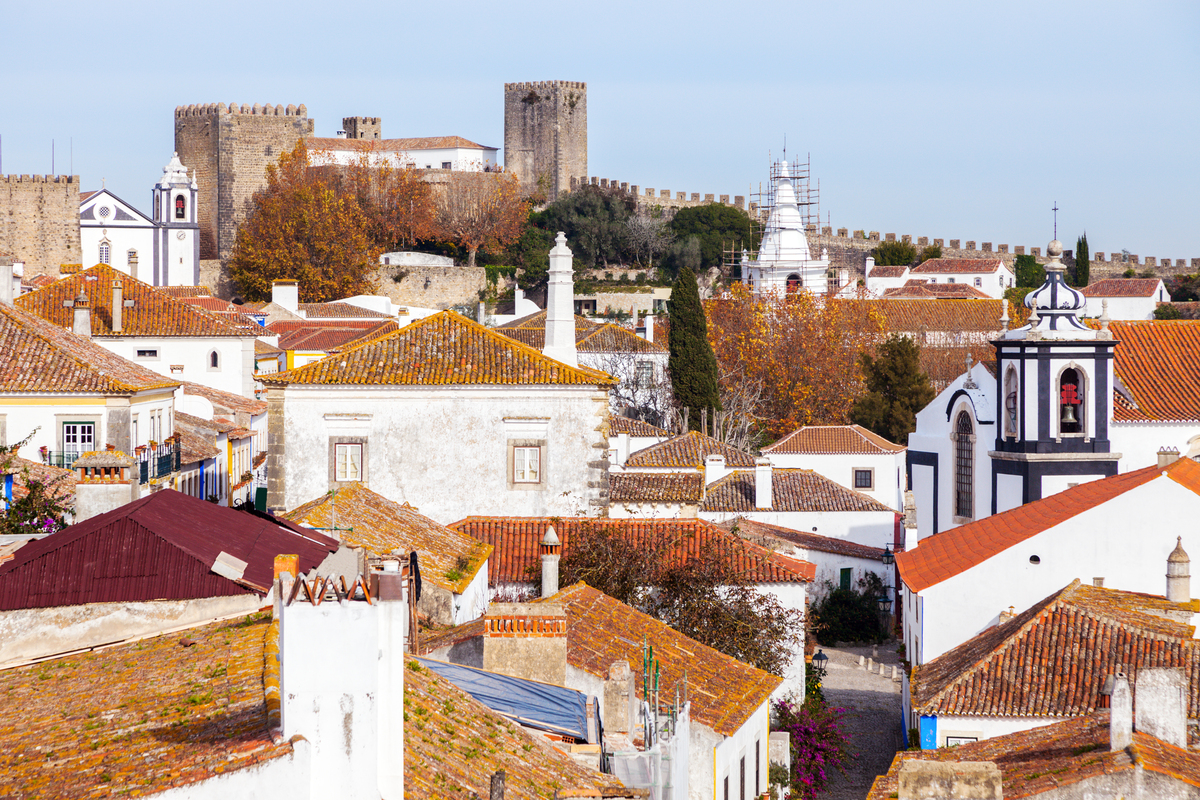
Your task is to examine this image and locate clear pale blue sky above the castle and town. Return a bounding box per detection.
[7,0,1200,259]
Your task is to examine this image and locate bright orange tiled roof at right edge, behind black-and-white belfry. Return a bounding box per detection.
[1109,319,1200,422]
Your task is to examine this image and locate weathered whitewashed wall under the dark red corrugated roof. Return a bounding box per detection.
[0,594,262,664]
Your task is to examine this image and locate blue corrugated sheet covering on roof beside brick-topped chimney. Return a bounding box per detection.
[416,657,594,744]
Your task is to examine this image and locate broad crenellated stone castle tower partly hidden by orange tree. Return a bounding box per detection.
[175,103,313,263]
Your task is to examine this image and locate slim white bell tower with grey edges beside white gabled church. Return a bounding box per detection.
[151,152,200,287]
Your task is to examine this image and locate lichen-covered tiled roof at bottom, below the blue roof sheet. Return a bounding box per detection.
[404,643,624,800]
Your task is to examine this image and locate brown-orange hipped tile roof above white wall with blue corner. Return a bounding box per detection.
[912,579,1200,718]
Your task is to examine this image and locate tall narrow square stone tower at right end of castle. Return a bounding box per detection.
[504,80,588,200]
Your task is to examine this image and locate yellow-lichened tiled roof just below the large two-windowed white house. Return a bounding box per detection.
[282,483,492,595]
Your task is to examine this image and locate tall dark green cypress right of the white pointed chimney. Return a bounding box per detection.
[667,266,721,431]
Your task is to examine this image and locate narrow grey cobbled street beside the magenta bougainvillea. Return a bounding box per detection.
[818,644,904,800]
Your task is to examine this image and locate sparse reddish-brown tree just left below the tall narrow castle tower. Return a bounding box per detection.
[437,172,529,266]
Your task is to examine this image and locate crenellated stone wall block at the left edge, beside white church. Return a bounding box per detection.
[0,175,83,279]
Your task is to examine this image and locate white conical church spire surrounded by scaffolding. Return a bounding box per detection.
[742,161,829,294]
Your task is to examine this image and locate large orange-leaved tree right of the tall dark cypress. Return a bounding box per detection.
[706,283,887,439]
